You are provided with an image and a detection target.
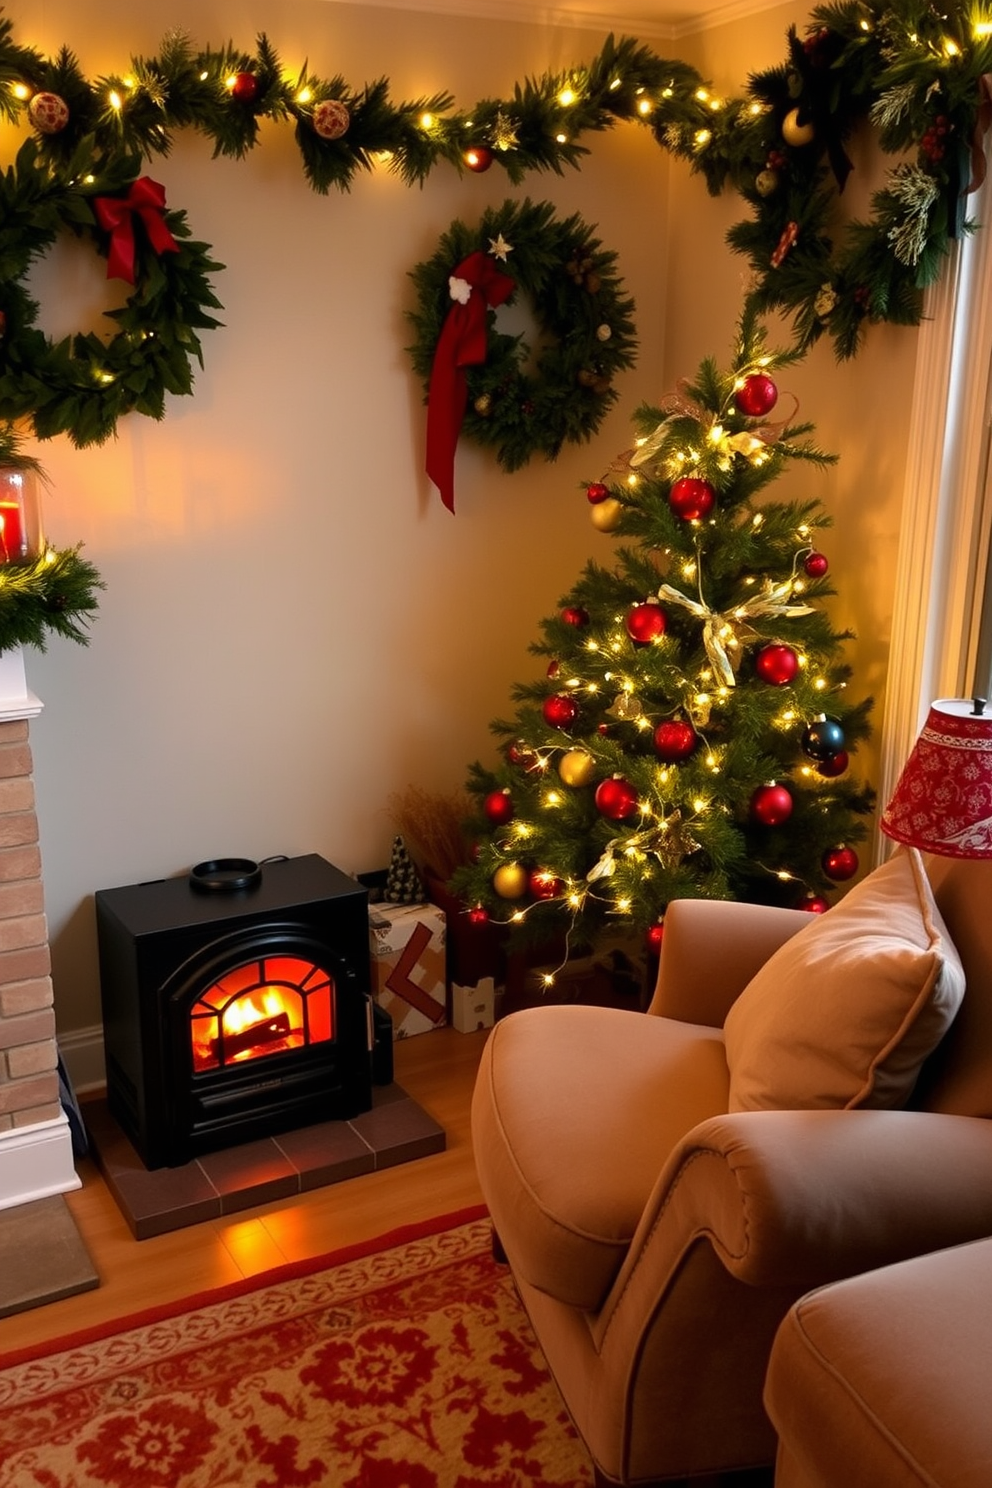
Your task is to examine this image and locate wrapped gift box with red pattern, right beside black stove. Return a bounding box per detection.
[369,903,446,1039]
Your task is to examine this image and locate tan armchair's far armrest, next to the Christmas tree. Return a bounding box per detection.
[648,899,809,1028]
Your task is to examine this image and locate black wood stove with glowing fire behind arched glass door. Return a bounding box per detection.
[95,854,373,1168]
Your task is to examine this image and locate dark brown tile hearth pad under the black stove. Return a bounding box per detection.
[87,1085,445,1240]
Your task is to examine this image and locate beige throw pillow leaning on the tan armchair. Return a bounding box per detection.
[724,848,964,1112]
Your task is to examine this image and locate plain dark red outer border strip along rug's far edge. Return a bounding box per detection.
[0,1204,489,1369]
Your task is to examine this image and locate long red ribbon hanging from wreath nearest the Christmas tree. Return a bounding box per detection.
[427,251,516,512]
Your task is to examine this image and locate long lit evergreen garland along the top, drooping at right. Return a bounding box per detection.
[0,0,992,377]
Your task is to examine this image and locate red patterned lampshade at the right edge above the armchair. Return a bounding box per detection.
[880,698,992,857]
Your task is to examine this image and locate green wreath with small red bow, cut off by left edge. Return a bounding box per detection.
[0,140,223,446]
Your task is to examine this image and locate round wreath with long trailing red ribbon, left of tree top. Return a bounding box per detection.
[408,199,637,510]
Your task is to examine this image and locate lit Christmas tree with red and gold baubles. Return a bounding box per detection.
[452,312,873,946]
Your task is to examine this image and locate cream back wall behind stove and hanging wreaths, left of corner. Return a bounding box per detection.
[0,0,668,1033]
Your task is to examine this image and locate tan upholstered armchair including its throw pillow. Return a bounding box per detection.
[473,853,992,1484]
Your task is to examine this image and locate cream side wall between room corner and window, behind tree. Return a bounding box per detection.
[665,4,918,821]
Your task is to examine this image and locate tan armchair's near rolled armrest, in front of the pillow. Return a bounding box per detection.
[648,1110,992,1290]
